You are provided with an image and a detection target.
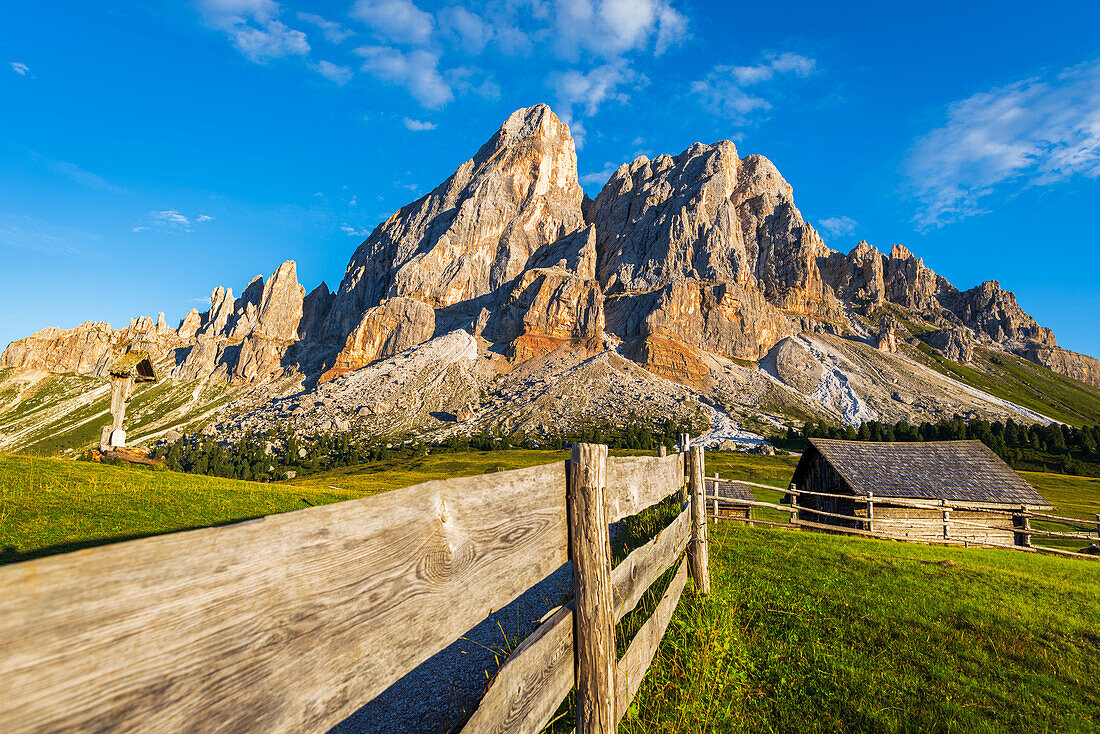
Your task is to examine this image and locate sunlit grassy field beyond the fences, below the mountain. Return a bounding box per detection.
[0,450,1100,562]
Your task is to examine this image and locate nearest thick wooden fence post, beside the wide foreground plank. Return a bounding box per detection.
[565,443,616,734]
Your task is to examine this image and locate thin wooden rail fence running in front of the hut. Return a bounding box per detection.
[704,474,1100,560]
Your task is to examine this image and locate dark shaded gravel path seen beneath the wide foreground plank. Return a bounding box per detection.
[330,563,573,734]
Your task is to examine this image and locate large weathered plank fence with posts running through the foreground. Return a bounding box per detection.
[0,445,710,734]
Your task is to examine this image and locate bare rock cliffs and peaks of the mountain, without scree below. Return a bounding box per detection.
[0,105,1100,398]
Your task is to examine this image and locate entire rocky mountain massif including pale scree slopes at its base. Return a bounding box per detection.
[0,105,1100,448]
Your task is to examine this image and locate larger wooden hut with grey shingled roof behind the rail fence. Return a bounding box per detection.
[792,438,1051,546]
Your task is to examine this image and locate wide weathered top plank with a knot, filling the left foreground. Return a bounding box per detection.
[0,463,567,734]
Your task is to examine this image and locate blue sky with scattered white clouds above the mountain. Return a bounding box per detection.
[0,0,1100,354]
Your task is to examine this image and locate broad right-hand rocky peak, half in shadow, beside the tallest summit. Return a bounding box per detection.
[590,141,846,359]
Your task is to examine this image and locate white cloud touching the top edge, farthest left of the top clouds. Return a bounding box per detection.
[199,0,309,63]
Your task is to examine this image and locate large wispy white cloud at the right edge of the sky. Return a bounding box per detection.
[905,61,1100,228]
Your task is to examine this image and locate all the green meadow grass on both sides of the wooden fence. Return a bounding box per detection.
[0,451,1100,734]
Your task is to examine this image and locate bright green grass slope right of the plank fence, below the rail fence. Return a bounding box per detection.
[619,524,1100,733]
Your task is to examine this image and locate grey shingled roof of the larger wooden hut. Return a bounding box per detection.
[795,438,1049,505]
